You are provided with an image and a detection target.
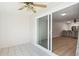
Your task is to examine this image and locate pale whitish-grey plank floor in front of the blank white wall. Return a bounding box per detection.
[0,44,39,56]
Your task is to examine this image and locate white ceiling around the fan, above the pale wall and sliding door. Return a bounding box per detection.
[0,2,75,16]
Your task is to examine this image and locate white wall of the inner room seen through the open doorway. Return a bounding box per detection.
[52,21,79,37]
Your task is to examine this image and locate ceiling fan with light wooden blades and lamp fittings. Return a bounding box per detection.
[19,2,47,13]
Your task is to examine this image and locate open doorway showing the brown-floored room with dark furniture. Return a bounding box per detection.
[52,4,79,56]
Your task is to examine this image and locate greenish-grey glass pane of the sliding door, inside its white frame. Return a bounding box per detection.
[37,16,48,48]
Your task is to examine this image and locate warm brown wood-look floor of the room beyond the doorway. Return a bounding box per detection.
[52,37,77,56]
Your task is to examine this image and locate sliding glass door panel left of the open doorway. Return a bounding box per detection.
[37,15,52,50]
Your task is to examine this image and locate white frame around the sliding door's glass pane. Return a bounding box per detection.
[34,13,52,52]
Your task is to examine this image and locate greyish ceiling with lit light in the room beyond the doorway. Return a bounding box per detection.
[53,3,79,21]
